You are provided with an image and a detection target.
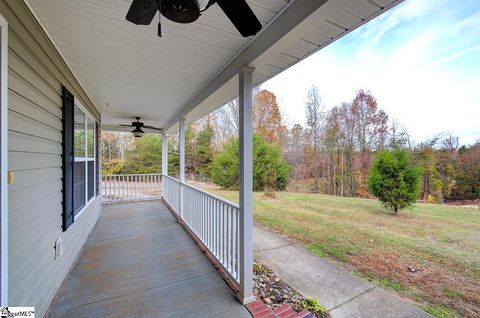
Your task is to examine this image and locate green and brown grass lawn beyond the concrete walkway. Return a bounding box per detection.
[195,187,480,317]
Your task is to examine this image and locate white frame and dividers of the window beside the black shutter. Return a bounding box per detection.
[73,97,98,222]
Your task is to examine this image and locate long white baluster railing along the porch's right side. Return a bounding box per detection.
[163,175,240,283]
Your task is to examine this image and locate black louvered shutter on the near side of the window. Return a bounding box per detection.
[62,86,75,231]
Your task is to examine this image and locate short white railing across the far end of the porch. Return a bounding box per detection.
[101,174,162,203]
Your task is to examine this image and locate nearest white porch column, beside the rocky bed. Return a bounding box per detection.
[238,66,255,304]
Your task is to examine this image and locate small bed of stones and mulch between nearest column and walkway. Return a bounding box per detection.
[253,261,330,318]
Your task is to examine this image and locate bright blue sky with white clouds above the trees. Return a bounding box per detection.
[262,0,480,144]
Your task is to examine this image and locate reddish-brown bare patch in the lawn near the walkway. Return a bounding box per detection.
[350,250,480,317]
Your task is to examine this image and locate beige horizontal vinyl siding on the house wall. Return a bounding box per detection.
[0,1,101,317]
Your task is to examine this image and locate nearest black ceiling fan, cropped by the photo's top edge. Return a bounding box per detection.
[126,0,262,37]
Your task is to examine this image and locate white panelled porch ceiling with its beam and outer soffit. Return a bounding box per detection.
[25,0,402,131]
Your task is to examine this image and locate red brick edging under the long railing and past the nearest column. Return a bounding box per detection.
[162,199,315,318]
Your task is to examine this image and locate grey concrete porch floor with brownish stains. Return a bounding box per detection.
[47,201,250,317]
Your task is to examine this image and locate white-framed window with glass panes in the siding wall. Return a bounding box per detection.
[73,101,97,217]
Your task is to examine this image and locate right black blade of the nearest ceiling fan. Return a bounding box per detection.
[217,0,262,37]
